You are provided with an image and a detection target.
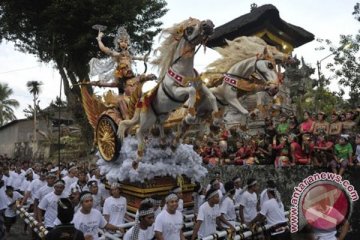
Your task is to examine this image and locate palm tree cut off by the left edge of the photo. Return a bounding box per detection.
[0,83,19,126]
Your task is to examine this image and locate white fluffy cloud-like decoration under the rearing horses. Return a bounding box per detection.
[97,137,207,182]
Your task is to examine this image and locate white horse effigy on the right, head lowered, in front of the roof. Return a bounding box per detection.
[178,37,283,138]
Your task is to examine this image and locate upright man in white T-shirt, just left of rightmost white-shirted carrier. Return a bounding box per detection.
[239,178,260,224]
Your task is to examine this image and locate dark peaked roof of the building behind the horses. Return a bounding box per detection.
[207,4,314,48]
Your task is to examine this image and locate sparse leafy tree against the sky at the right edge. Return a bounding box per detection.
[321,3,360,108]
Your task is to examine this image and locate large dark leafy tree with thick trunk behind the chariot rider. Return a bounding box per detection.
[0,0,167,146]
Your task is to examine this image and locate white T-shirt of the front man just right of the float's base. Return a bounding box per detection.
[197,202,220,238]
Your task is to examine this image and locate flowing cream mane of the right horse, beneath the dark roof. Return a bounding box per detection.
[205,36,285,87]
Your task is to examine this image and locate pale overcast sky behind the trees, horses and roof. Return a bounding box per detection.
[0,0,359,118]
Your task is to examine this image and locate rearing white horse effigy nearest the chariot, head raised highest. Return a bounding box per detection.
[118,18,218,166]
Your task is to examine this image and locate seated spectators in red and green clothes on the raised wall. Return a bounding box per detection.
[194,108,360,175]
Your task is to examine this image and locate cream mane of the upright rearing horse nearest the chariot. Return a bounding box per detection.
[151,18,200,79]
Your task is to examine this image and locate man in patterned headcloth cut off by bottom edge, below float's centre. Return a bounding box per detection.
[123,201,155,240]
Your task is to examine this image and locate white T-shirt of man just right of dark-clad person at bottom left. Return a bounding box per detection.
[73,208,107,240]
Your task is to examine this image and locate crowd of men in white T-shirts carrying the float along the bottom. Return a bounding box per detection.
[0,162,346,240]
